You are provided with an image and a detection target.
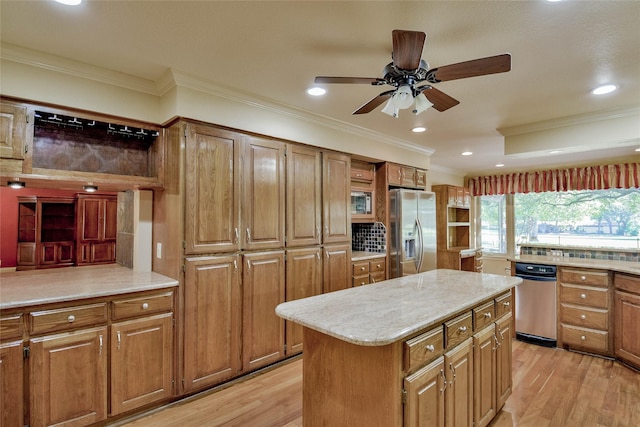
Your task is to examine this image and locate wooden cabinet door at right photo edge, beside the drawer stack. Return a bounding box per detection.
[614,291,640,367]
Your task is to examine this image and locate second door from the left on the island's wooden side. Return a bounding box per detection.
[444,338,473,427]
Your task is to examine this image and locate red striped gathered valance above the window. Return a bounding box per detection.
[467,163,640,196]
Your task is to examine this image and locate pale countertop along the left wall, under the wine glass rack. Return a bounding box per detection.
[0,264,178,310]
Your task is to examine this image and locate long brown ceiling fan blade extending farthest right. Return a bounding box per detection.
[427,53,511,83]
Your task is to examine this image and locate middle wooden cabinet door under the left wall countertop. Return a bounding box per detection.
[29,326,107,427]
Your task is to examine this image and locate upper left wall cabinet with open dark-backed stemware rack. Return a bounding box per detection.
[0,100,164,190]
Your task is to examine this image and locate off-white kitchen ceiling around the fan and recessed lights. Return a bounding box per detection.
[0,0,640,174]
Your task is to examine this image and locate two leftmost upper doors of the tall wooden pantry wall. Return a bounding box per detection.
[185,124,285,254]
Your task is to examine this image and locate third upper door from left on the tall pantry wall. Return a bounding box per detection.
[287,145,322,247]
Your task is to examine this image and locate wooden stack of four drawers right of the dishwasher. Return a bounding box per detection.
[558,267,613,355]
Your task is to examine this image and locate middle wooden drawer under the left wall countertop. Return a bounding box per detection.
[29,303,107,334]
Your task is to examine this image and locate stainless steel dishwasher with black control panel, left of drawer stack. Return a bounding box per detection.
[515,262,557,347]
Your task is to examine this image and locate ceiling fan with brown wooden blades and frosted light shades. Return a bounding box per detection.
[315,30,511,117]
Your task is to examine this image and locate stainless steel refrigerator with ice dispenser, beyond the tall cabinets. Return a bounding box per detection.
[389,189,437,278]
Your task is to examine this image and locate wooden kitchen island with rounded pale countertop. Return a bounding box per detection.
[276,270,521,427]
